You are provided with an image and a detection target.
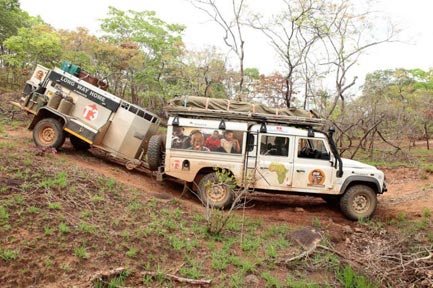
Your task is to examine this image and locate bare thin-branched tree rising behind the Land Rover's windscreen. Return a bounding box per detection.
[323,0,397,117]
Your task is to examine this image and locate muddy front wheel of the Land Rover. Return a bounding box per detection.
[340,185,377,220]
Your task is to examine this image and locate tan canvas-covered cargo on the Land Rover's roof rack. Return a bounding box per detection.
[166,96,327,126]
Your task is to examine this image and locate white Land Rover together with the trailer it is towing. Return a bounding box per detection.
[15,63,387,220]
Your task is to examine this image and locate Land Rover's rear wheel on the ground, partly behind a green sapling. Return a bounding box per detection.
[198,172,234,209]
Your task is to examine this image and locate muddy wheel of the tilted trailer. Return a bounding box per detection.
[33,118,65,149]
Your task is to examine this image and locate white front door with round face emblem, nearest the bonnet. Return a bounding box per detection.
[292,137,335,193]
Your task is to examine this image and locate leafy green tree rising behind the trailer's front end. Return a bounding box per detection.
[101,7,184,108]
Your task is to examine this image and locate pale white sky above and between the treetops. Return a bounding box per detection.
[20,0,433,92]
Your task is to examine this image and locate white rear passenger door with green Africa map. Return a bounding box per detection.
[255,134,293,190]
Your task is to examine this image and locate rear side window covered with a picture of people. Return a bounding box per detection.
[171,126,243,154]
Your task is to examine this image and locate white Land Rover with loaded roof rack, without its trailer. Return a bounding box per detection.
[148,96,386,220]
